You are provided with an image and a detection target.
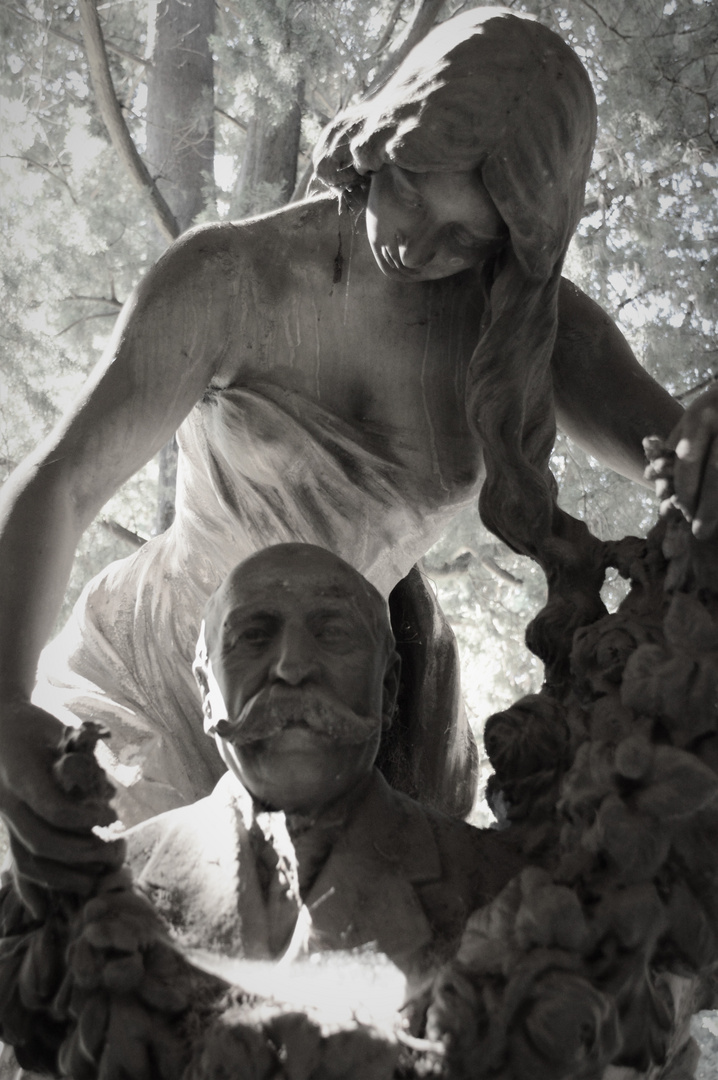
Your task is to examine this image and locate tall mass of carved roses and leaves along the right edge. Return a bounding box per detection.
[429,508,718,1080]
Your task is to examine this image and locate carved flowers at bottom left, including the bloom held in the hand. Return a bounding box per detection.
[0,724,226,1080]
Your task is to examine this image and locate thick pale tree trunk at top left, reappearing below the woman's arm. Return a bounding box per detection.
[147,0,215,532]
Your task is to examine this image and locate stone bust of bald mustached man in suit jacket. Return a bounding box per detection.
[126,543,517,987]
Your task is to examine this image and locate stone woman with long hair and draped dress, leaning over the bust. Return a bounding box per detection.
[0,9,696,880]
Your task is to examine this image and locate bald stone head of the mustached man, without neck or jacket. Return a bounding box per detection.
[194,543,399,813]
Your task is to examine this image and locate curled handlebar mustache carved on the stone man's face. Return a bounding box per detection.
[214,687,381,746]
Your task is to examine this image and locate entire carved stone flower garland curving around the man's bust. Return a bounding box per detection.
[0,441,718,1080]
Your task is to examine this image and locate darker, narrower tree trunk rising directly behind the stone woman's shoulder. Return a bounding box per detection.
[232,79,304,216]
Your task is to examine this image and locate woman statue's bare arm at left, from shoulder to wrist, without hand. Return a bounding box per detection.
[0,231,229,700]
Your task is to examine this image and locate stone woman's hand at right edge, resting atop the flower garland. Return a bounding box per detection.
[647,387,718,540]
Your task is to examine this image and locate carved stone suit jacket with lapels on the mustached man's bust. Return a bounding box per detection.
[120,770,519,982]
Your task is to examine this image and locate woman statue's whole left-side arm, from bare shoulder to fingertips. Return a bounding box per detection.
[0,230,228,883]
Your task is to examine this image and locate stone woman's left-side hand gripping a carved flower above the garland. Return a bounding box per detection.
[0,702,124,894]
